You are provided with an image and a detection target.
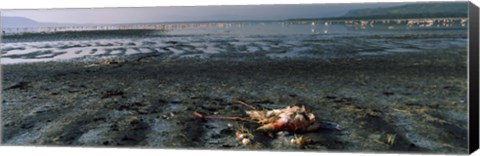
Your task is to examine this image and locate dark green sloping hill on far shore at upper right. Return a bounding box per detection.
[342,2,468,18]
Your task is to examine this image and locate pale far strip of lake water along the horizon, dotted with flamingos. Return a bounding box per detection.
[2,18,468,35]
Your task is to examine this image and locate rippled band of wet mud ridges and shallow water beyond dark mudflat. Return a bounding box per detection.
[1,29,467,64]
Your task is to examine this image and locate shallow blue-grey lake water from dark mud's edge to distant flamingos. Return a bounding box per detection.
[1,22,467,64]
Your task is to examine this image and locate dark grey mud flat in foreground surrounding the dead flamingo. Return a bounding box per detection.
[2,49,468,154]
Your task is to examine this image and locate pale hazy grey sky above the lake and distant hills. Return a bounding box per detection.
[1,3,405,24]
